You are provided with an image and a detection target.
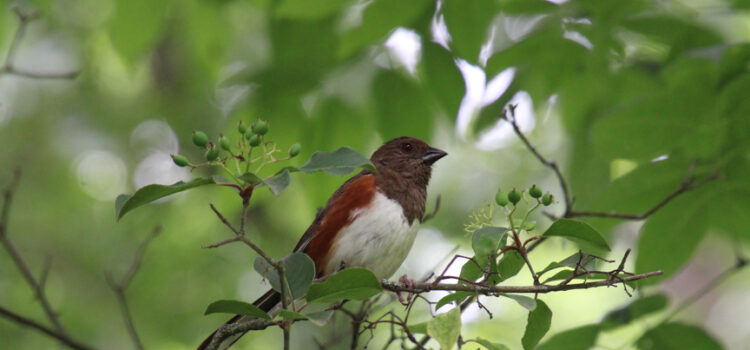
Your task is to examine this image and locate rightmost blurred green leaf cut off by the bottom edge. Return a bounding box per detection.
[636,322,723,350]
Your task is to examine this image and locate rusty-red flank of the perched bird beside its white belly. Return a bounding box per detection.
[294,170,376,276]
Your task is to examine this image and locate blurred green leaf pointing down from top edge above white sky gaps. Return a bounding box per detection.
[442,0,497,64]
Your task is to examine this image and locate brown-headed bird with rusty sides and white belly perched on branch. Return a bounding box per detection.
[198,137,447,350]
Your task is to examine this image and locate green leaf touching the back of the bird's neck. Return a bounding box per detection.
[299,147,375,176]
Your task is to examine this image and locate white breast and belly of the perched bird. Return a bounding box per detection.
[325,192,419,278]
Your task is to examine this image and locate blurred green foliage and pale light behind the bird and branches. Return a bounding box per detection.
[0,0,750,350]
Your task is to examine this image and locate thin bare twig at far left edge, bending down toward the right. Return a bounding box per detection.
[0,168,67,336]
